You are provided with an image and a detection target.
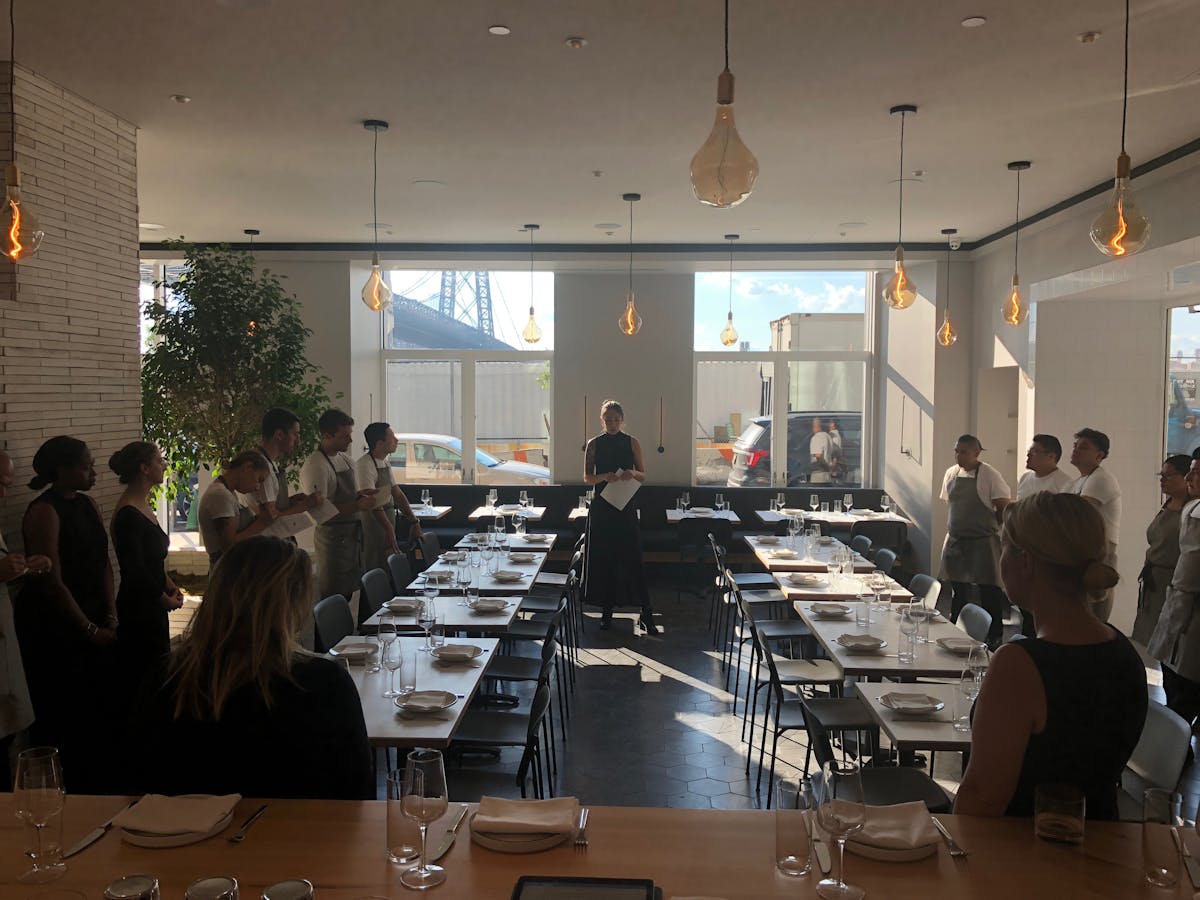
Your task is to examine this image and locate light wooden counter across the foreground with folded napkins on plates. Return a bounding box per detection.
[14,801,1185,900]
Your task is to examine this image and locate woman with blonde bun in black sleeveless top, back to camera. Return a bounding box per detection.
[954,492,1147,820]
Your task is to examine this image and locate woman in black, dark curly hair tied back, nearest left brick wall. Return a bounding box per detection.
[14,436,118,793]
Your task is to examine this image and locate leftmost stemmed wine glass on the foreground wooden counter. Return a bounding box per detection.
[12,746,67,884]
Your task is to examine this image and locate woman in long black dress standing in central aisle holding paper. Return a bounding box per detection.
[583,400,659,635]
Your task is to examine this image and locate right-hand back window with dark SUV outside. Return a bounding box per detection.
[694,271,875,487]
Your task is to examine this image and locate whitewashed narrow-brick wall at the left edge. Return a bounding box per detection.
[0,62,142,546]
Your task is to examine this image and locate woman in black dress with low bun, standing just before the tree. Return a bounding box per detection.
[108,440,184,696]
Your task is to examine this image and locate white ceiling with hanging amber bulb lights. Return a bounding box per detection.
[16,0,1200,244]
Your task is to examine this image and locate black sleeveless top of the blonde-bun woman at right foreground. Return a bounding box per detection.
[1006,625,1147,820]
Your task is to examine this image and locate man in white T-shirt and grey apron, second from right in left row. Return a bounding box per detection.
[300,409,374,600]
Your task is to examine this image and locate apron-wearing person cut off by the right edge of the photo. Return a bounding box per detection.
[1146,451,1200,725]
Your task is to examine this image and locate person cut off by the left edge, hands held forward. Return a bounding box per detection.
[0,450,50,786]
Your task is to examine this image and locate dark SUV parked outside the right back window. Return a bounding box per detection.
[725,410,863,487]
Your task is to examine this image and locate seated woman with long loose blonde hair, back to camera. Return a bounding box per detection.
[131,536,374,799]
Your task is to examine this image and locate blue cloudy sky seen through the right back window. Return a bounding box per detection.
[695,271,868,350]
